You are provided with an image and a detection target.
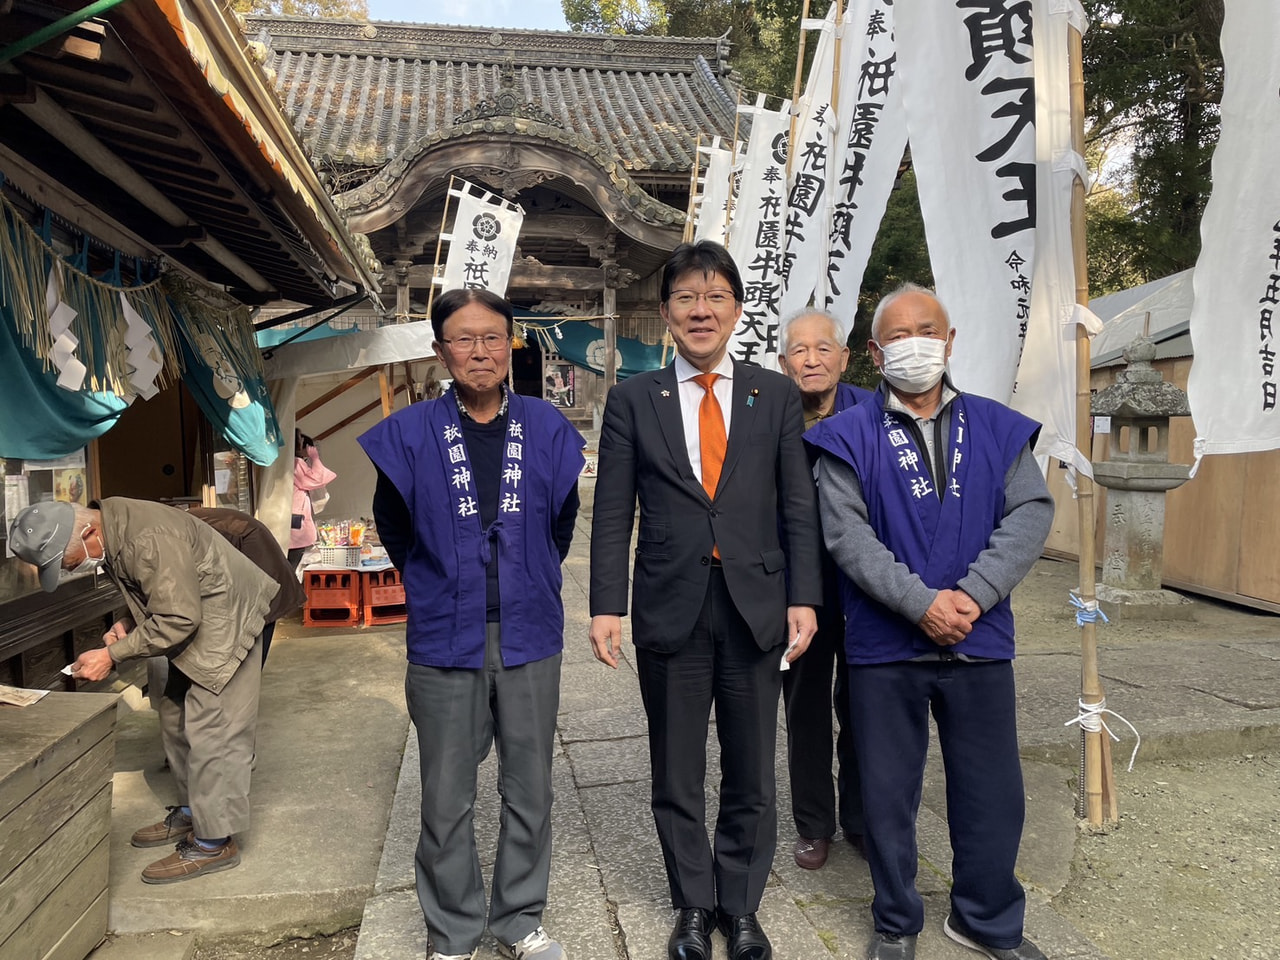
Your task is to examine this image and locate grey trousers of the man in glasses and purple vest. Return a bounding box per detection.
[404,623,561,954]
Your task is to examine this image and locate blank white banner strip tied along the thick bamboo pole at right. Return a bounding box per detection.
[1012,0,1102,476]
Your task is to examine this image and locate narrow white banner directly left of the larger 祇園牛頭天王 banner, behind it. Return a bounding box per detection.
[778,4,837,316]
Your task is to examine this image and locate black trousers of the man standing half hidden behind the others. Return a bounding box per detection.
[782,608,865,840]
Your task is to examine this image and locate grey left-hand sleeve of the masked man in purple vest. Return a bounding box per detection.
[817,453,936,623]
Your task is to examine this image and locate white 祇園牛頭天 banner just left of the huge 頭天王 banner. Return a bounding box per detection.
[815,0,906,337]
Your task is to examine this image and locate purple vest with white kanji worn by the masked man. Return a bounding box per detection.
[805,392,1039,663]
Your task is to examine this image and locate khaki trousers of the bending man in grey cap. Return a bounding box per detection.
[159,637,262,840]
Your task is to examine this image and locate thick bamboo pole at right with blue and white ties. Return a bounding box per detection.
[1068,18,1116,827]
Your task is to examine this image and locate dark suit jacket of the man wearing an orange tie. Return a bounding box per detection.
[591,361,822,650]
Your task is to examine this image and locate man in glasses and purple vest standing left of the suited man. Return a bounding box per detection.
[360,289,584,960]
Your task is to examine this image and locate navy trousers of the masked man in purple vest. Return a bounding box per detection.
[849,659,1025,948]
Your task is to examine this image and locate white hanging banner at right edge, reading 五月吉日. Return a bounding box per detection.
[1187,0,1280,466]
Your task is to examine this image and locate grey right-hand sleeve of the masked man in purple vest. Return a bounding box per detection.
[956,445,1053,613]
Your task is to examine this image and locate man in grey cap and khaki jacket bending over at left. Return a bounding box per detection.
[9,497,279,883]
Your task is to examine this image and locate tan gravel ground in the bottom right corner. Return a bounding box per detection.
[1053,754,1280,960]
